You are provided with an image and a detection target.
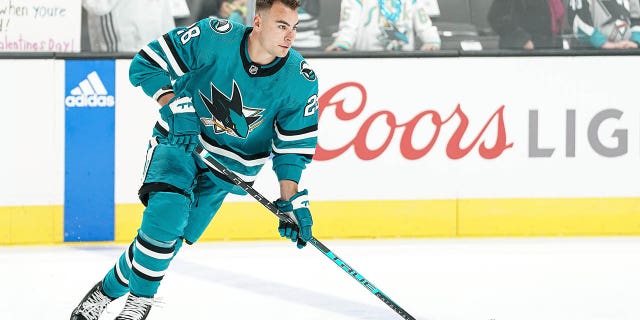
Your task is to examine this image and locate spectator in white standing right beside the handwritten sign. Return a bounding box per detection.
[82,0,175,52]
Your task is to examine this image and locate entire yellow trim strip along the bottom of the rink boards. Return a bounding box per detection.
[0,197,640,245]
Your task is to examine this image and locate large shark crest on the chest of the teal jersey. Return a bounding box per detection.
[199,80,264,138]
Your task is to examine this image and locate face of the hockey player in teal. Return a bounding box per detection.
[258,2,298,57]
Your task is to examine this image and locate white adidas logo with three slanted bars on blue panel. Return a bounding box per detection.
[64,71,115,107]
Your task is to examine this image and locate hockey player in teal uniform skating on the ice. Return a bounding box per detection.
[71,0,318,320]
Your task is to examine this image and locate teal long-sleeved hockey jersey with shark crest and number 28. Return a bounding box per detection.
[129,18,318,194]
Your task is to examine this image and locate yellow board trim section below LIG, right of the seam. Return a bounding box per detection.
[458,198,640,237]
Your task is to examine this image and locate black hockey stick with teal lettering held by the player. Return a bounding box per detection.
[195,146,416,320]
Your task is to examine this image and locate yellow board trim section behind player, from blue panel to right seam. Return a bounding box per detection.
[115,200,456,242]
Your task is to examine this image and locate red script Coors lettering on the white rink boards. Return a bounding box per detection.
[314,82,513,161]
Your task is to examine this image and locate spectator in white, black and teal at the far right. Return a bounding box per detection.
[569,0,640,49]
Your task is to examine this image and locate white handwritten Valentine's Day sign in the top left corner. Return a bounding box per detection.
[0,0,81,52]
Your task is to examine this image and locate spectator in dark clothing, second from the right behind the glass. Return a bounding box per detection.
[488,0,565,50]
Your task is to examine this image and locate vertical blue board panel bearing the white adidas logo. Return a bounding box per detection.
[64,60,115,241]
